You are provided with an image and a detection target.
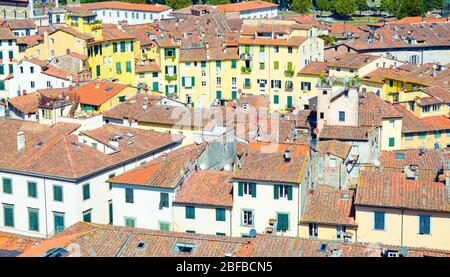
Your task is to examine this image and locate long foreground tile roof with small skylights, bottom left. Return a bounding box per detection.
[21,222,248,257]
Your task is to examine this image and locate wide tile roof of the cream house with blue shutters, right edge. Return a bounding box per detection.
[355,170,450,212]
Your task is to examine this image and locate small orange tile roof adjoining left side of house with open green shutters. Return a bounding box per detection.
[174,170,233,207]
